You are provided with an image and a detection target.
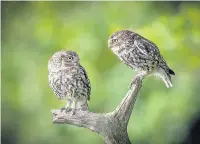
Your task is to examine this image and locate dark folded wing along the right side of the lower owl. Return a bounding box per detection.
[79,65,91,101]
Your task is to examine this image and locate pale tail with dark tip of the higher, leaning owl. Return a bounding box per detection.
[156,67,175,88]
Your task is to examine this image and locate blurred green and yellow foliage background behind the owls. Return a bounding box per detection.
[1,2,200,144]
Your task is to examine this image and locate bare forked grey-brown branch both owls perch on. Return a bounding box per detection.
[51,76,142,144]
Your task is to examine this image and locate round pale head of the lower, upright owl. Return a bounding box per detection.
[48,50,79,72]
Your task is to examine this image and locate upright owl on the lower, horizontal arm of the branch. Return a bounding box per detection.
[48,50,91,114]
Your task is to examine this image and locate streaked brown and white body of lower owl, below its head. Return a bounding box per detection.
[51,67,90,100]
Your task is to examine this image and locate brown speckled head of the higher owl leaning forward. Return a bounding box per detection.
[108,30,135,49]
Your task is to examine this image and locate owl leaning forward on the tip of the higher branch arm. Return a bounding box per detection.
[108,30,175,88]
